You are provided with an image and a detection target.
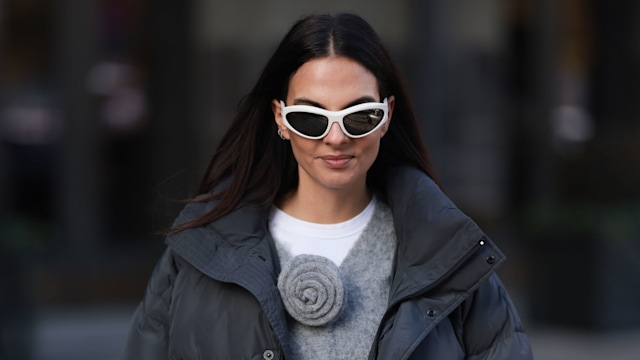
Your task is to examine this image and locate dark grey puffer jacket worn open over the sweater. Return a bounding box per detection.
[124,168,533,360]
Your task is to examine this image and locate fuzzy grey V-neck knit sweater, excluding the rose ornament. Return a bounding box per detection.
[275,201,396,360]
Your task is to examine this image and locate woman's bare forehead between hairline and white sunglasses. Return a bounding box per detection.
[287,56,379,110]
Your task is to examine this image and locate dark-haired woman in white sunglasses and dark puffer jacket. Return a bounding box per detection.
[125,14,531,360]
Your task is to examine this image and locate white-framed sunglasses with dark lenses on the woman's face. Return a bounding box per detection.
[280,98,389,140]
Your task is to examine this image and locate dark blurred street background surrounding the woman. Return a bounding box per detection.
[0,0,640,360]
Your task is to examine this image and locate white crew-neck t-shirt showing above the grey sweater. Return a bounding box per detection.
[269,196,377,266]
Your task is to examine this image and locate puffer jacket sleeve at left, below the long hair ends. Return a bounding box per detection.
[123,249,177,360]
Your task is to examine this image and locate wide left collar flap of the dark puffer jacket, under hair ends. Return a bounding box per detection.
[166,202,289,352]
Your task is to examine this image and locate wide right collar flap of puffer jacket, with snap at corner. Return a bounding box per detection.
[387,167,505,304]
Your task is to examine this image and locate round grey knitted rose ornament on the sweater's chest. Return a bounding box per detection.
[278,254,346,326]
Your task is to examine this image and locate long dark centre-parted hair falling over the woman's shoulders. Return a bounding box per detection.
[170,13,437,233]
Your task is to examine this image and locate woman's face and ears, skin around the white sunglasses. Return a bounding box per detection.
[272,56,394,195]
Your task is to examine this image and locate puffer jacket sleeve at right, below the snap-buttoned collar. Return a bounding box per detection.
[460,274,533,360]
